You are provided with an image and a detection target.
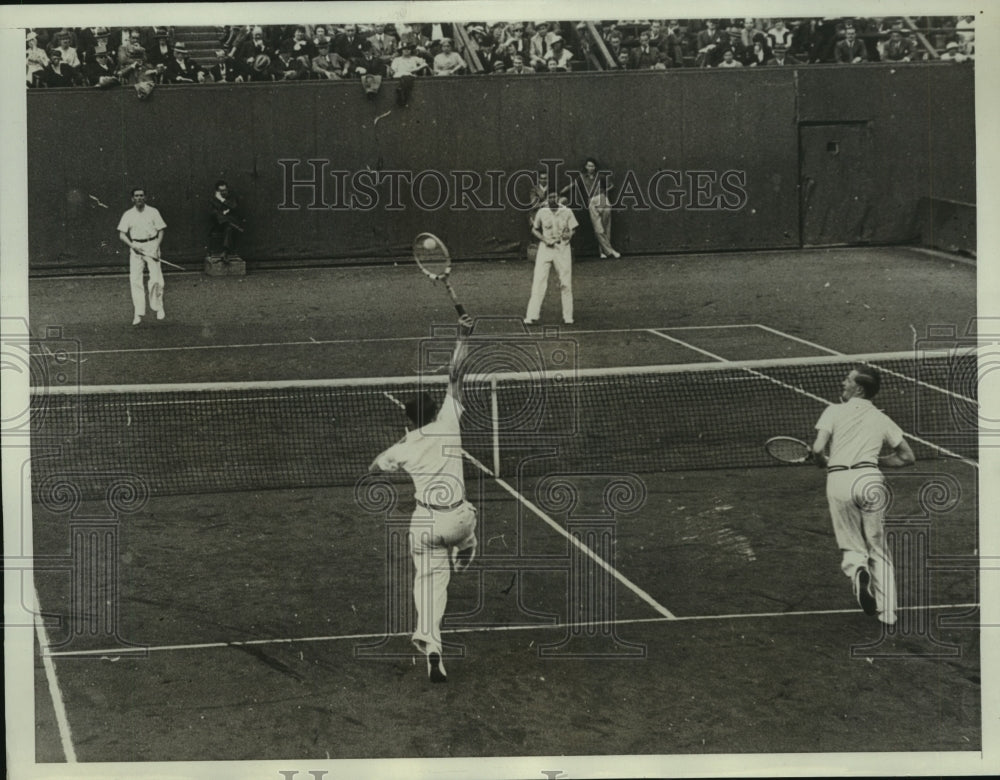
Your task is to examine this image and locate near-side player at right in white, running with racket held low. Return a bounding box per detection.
[812,365,914,626]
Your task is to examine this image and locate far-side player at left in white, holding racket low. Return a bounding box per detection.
[118,187,167,325]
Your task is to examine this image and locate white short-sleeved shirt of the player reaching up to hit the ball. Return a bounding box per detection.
[375,393,465,506]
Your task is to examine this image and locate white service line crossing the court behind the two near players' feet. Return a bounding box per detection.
[46,602,980,660]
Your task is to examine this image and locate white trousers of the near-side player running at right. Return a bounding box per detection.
[826,469,896,623]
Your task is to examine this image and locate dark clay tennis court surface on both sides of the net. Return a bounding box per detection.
[30,248,983,763]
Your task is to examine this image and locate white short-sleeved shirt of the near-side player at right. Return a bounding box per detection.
[816,398,903,468]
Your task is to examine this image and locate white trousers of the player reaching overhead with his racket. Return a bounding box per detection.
[409,501,477,654]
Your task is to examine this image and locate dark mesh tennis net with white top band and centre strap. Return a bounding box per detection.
[32,353,978,495]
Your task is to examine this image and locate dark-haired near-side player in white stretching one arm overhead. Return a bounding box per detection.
[369,315,477,682]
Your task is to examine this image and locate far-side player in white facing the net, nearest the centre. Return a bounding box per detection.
[524,187,578,325]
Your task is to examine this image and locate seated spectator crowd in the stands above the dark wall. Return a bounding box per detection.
[25,15,975,92]
